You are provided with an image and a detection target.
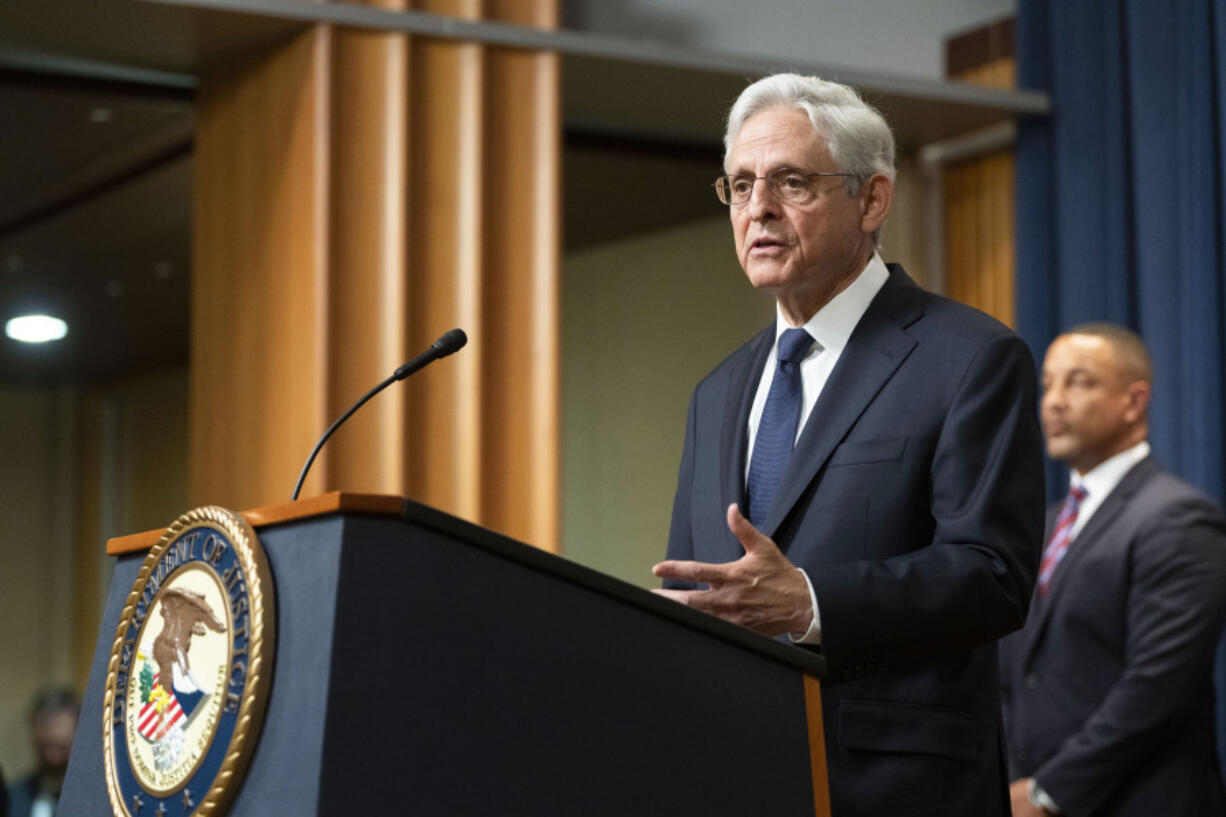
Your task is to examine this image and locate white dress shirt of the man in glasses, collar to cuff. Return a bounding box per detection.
[744,253,890,644]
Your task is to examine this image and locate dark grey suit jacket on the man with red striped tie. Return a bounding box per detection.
[1000,459,1226,817]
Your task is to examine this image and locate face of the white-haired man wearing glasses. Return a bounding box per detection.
[727,108,878,310]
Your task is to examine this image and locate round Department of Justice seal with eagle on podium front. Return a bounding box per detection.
[103,507,276,817]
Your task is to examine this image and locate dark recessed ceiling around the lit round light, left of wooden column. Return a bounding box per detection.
[0,71,192,384]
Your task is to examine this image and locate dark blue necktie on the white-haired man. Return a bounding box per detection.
[745,329,813,527]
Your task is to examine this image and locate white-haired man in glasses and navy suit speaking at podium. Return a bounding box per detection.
[655,75,1043,817]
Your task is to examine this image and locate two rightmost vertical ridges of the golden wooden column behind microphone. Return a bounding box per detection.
[406,0,560,550]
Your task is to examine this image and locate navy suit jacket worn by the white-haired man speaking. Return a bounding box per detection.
[668,265,1043,817]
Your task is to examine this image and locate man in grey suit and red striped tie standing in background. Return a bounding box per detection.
[1002,324,1226,817]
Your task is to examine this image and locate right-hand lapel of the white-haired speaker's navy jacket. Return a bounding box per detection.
[742,265,923,537]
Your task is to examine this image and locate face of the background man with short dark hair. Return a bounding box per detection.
[1041,335,1144,474]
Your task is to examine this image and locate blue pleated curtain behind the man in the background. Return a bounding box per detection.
[1016,0,1226,775]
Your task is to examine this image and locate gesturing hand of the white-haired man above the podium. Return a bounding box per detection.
[651,504,813,635]
